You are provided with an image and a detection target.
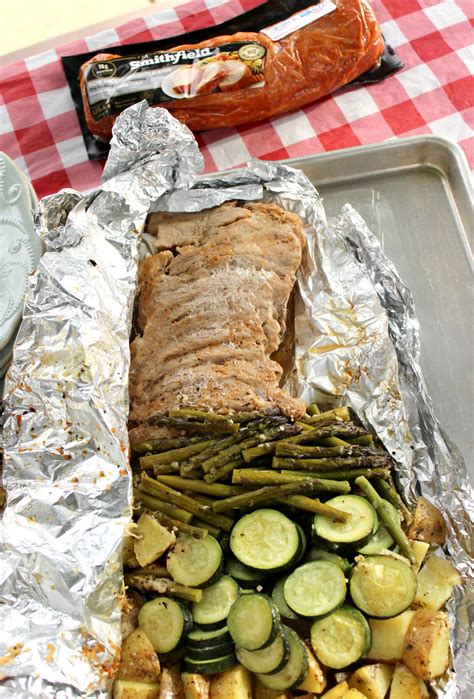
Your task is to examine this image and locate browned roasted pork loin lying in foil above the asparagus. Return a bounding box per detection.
[130,202,305,439]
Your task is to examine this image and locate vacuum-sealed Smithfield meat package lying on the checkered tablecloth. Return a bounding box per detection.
[63,0,401,155]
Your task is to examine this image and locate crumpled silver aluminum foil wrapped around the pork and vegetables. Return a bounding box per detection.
[0,103,473,698]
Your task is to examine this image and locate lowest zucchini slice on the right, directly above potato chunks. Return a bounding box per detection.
[311,607,370,670]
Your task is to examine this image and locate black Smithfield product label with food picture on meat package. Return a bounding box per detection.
[85,41,266,121]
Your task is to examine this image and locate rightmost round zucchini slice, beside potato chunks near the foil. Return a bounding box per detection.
[350,556,416,619]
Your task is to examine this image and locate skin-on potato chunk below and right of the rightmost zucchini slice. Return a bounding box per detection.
[402,609,449,680]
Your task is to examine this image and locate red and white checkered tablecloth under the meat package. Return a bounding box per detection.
[0,0,474,196]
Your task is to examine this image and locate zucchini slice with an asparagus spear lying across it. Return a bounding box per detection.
[314,495,379,546]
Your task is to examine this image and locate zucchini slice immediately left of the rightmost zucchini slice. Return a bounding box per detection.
[283,561,347,616]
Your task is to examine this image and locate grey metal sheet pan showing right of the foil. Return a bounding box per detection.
[286,136,474,481]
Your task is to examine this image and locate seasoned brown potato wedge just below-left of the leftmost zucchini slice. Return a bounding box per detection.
[117,629,160,682]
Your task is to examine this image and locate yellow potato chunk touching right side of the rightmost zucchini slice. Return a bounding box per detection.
[415,556,461,611]
